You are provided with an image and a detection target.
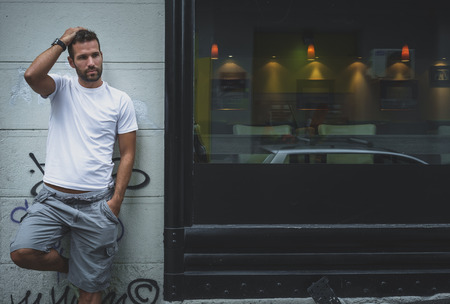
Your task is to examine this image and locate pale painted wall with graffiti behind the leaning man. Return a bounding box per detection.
[0,0,165,303]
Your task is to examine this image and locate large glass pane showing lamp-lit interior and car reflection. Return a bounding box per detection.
[194,0,450,165]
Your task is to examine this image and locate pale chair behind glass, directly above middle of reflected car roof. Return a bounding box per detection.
[318,124,376,164]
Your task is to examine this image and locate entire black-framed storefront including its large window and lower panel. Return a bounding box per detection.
[164,0,450,303]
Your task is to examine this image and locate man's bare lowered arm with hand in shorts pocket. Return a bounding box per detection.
[108,131,136,216]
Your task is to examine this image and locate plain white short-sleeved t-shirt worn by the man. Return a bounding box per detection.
[44,74,138,191]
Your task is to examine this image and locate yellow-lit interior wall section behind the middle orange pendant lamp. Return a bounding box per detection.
[253,33,357,93]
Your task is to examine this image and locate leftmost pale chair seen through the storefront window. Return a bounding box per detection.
[233,124,291,163]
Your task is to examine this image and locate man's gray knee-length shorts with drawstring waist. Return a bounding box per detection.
[11,185,119,292]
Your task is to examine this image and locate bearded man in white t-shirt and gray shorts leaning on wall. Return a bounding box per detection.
[11,27,138,304]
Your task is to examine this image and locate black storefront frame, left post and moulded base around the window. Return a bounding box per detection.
[164,0,450,301]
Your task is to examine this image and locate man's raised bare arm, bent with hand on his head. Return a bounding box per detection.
[25,27,83,96]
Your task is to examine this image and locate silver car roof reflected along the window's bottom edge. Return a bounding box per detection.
[263,146,428,165]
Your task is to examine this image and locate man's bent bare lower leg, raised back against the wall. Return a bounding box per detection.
[11,248,69,273]
